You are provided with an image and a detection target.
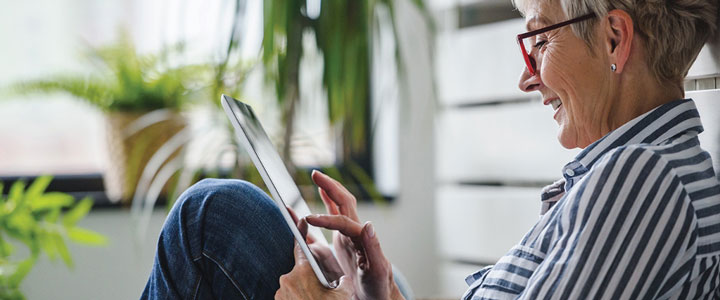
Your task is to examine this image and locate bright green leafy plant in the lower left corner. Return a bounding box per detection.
[0,176,107,299]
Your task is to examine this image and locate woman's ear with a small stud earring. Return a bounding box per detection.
[603,9,635,73]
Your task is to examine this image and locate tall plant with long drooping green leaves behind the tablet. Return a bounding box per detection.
[261,0,431,202]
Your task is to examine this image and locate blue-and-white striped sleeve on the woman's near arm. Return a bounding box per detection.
[519,147,697,299]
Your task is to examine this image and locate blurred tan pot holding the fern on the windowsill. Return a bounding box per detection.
[104,112,187,205]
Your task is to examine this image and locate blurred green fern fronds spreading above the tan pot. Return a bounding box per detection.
[10,31,205,112]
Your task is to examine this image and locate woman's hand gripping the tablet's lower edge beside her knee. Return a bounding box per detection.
[275,242,354,300]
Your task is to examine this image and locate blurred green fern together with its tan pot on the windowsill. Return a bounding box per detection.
[14,31,204,201]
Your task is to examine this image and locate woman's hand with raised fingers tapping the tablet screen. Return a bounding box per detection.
[306,171,402,299]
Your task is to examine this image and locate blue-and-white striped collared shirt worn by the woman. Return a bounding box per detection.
[463,100,720,299]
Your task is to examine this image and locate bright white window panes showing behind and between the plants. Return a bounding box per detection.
[0,0,397,203]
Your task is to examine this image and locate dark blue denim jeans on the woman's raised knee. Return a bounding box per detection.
[141,179,409,299]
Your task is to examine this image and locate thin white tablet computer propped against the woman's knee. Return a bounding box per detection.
[220,95,338,288]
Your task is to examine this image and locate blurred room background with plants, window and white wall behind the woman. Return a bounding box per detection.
[0,0,720,299]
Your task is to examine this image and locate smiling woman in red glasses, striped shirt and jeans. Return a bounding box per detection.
[144,0,720,299]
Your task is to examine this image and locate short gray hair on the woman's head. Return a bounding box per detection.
[512,0,718,84]
